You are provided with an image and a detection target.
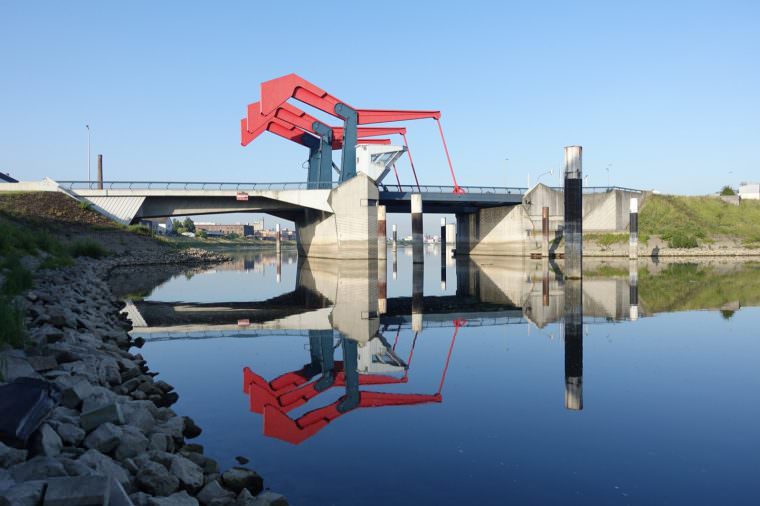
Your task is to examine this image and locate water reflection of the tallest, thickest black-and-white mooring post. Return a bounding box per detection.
[565,279,583,410]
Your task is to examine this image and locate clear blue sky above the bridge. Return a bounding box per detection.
[0,1,760,228]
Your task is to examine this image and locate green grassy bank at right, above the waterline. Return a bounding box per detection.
[639,195,760,248]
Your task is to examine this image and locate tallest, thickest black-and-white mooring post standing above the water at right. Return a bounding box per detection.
[563,146,583,279]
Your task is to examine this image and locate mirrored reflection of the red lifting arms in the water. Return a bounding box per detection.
[243,320,466,444]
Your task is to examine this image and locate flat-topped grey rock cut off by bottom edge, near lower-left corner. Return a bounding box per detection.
[44,476,132,506]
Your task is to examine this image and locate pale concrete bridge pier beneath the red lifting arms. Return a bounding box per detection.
[296,174,379,260]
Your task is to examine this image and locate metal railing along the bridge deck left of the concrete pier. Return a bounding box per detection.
[57,181,338,191]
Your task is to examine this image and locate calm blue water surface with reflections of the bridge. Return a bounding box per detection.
[114,249,760,505]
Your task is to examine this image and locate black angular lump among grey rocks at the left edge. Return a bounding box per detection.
[0,378,61,448]
